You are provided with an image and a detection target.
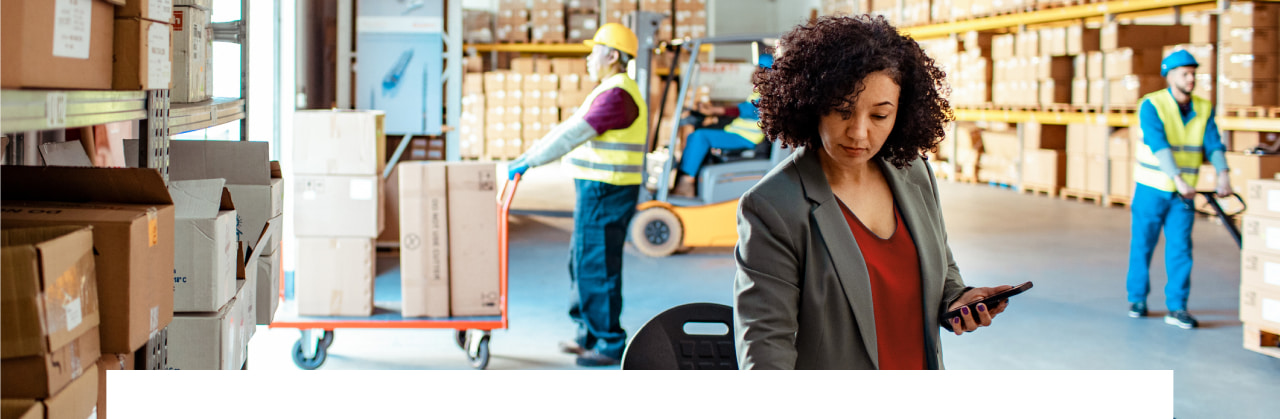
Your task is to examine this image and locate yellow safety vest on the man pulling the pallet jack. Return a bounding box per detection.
[1134,88,1213,192]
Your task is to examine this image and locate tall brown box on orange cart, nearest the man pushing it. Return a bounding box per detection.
[446,163,500,316]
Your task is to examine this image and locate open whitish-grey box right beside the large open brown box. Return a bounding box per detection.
[169,179,240,313]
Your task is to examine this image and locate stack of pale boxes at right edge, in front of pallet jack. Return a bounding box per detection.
[1241,179,1281,356]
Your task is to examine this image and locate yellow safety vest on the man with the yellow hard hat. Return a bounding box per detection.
[564,73,649,186]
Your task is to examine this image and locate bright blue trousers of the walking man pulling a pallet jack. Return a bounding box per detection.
[1126,185,1195,311]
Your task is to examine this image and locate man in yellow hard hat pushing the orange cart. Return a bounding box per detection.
[507,23,649,366]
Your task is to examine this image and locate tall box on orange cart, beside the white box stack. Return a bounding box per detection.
[400,161,453,316]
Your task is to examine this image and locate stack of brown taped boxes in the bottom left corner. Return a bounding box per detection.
[0,228,101,418]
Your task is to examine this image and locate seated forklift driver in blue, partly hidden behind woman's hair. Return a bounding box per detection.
[671,54,774,197]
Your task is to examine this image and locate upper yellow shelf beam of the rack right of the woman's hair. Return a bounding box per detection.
[902,0,1213,40]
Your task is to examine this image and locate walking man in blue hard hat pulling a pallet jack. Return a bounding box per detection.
[1126,50,1232,329]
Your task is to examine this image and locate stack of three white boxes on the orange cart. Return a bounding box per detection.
[292,110,386,316]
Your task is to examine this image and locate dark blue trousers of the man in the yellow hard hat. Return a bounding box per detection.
[569,179,641,359]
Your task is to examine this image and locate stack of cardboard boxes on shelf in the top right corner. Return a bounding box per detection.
[1220,1,1281,106]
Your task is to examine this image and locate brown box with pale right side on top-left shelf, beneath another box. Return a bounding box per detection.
[111,18,173,90]
